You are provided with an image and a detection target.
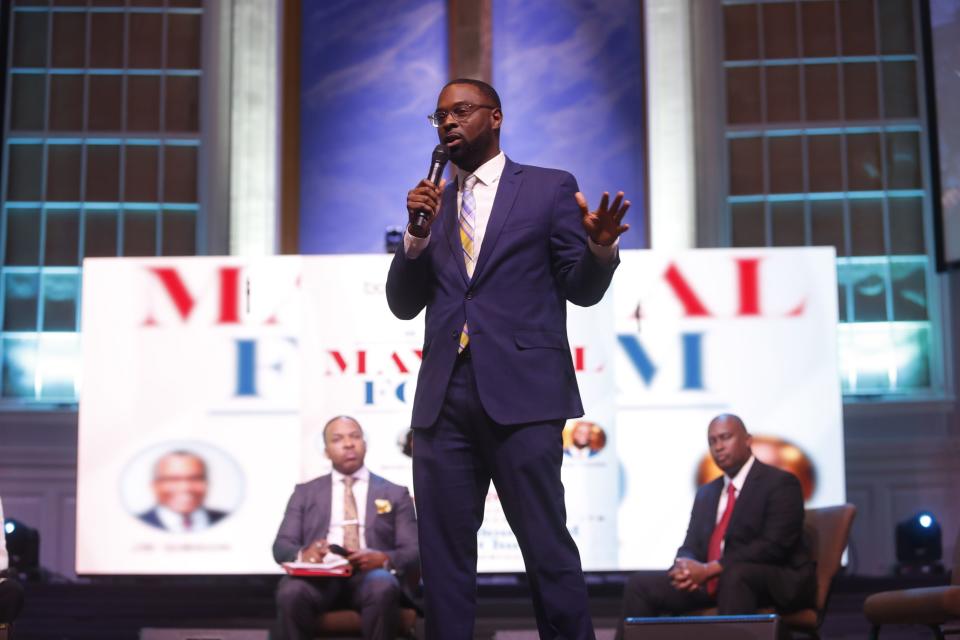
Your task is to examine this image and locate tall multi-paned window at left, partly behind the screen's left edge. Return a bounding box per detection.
[0,0,203,406]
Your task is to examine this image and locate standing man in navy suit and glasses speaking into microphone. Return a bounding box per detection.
[387,79,630,640]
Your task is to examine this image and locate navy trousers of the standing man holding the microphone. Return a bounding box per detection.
[413,353,594,640]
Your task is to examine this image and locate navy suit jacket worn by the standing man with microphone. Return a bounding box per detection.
[387,158,619,427]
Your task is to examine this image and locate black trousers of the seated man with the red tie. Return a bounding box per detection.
[616,563,817,640]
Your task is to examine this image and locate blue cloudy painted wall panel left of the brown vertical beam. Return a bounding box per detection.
[300,0,448,254]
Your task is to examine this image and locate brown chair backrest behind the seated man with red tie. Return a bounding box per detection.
[803,504,857,618]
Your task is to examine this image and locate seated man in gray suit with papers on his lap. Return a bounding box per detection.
[273,416,420,640]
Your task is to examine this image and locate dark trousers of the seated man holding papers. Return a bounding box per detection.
[276,569,401,640]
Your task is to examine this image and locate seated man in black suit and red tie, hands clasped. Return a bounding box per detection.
[617,415,817,639]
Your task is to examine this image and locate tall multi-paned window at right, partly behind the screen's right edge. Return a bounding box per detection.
[723,0,943,396]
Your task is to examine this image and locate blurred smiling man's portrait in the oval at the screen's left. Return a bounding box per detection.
[137,450,227,533]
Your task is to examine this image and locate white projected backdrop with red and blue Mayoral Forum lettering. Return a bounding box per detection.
[77,249,844,574]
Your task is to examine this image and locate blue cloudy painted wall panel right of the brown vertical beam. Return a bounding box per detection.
[493,0,647,248]
